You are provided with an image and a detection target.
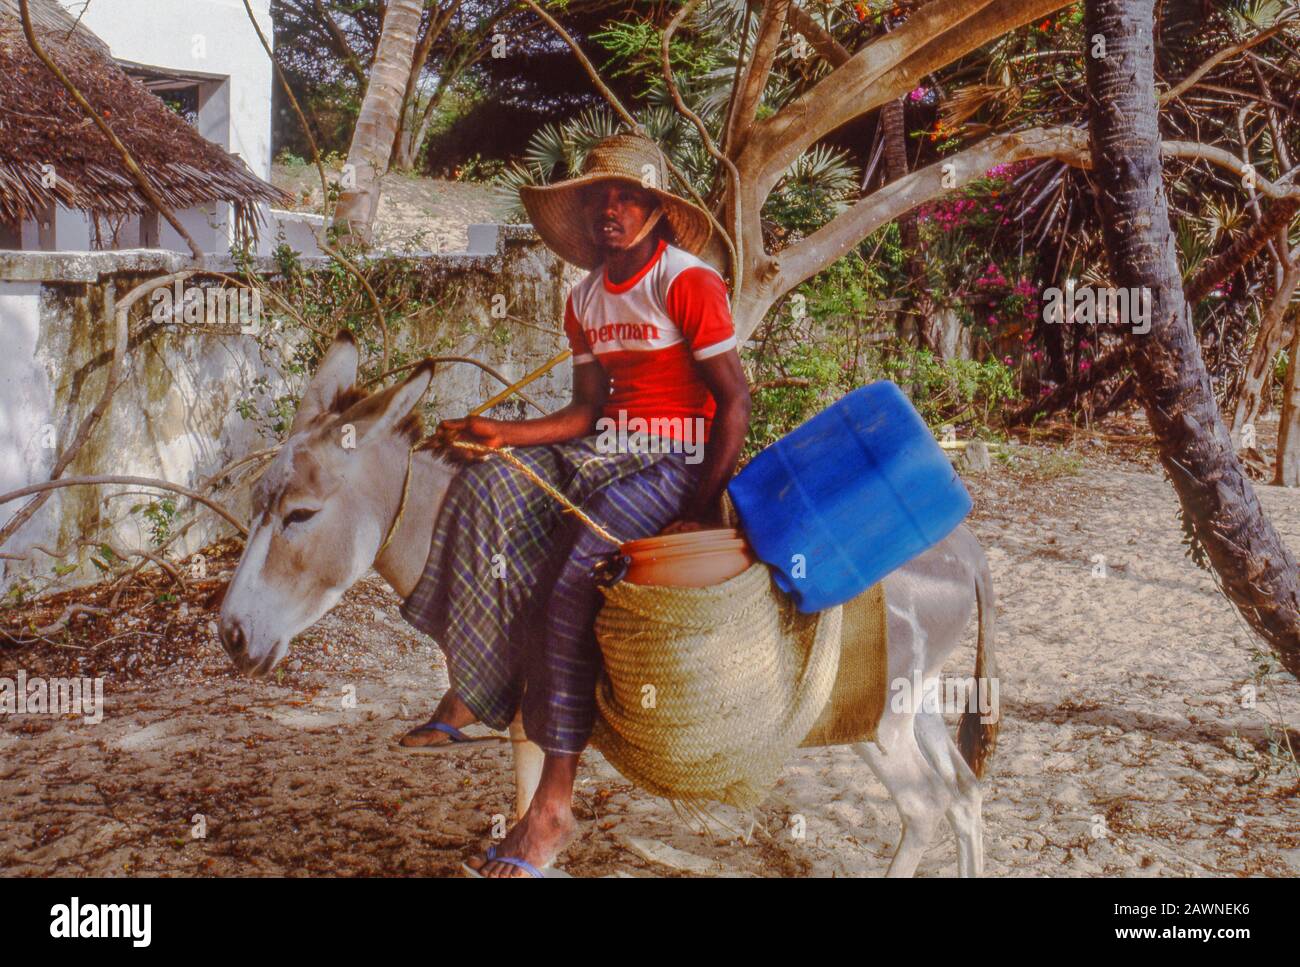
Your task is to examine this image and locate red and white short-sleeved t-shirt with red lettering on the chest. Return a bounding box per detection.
[564,239,736,441]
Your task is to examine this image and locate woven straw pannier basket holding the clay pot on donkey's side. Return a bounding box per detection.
[593,564,841,808]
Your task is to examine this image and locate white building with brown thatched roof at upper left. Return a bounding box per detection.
[0,0,316,253]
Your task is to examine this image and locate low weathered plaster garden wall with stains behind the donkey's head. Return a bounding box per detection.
[0,225,576,594]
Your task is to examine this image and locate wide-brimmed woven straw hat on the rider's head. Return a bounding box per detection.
[519,134,712,269]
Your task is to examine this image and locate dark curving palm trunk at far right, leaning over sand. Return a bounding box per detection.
[1084,0,1300,675]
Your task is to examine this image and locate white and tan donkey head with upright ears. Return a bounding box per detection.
[220,331,433,676]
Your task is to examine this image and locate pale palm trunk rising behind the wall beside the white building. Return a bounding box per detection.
[334,0,424,244]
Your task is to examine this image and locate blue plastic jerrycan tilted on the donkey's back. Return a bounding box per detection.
[728,380,971,612]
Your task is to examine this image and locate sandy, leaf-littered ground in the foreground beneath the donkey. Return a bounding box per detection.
[0,447,1300,876]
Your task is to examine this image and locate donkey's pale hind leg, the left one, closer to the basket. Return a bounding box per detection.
[853,711,952,876]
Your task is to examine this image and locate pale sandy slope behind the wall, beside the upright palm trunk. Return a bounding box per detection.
[272,165,499,252]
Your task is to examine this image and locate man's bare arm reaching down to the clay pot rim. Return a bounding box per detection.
[663,350,750,534]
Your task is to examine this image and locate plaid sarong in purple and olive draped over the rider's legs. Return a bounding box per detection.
[402,437,699,755]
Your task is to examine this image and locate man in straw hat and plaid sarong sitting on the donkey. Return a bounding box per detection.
[402,134,750,877]
